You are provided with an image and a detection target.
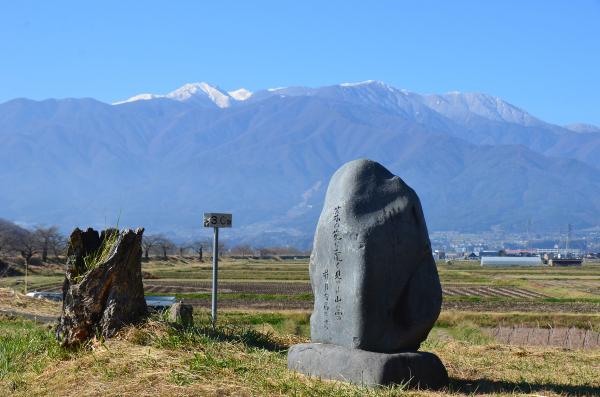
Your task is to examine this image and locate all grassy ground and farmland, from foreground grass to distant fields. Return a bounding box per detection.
[0,258,600,396]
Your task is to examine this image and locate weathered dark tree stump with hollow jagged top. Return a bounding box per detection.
[56,228,148,346]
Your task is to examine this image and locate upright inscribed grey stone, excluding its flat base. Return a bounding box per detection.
[310,160,442,353]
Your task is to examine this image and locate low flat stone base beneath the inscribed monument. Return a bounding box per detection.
[288,343,448,389]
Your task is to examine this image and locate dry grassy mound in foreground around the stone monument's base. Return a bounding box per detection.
[0,321,600,396]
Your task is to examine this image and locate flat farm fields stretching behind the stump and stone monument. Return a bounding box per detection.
[0,257,600,314]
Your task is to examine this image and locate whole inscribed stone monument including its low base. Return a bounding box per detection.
[288,159,448,388]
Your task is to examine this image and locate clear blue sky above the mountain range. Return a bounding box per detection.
[0,0,600,125]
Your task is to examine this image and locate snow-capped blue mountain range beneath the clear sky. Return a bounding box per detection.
[0,80,600,246]
